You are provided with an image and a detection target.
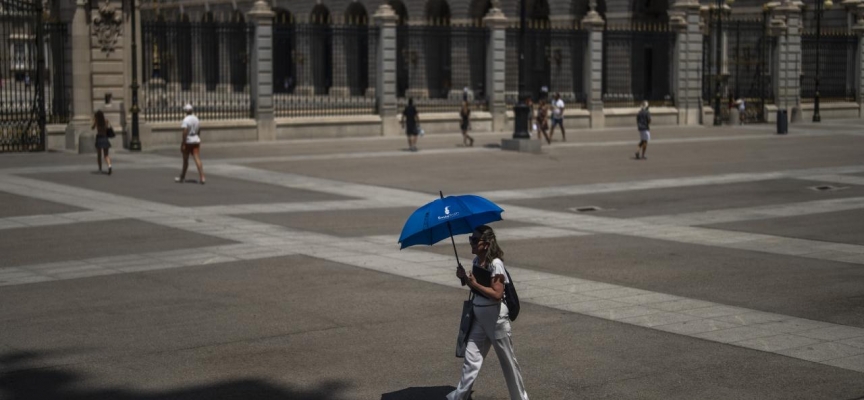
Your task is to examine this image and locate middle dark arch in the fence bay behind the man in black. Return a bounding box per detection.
[426,0,452,98]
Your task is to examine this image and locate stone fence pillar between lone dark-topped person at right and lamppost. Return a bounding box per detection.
[669,0,703,125]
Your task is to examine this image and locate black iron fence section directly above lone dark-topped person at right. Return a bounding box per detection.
[603,24,676,107]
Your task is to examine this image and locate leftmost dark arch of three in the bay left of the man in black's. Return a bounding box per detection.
[273,8,297,93]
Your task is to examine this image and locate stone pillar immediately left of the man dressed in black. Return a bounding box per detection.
[373,4,402,136]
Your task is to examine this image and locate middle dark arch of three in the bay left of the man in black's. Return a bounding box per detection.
[311,4,333,95]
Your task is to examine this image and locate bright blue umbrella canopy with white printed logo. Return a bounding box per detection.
[399,195,504,249]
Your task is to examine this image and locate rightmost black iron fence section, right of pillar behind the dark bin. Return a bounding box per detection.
[801,29,858,102]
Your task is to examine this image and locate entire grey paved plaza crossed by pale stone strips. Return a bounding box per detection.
[0,120,864,400]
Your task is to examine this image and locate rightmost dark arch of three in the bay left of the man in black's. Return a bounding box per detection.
[343,2,369,96]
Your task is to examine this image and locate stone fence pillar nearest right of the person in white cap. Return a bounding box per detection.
[249,0,276,141]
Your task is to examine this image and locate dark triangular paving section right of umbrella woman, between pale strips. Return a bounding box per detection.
[420,235,864,327]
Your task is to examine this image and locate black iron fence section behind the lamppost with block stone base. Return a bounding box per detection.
[505,21,588,108]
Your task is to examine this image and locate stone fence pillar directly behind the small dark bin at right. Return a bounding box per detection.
[770,0,801,122]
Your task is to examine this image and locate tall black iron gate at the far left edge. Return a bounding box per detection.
[0,0,45,153]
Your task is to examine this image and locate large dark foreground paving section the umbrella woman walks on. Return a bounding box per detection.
[0,257,864,400]
